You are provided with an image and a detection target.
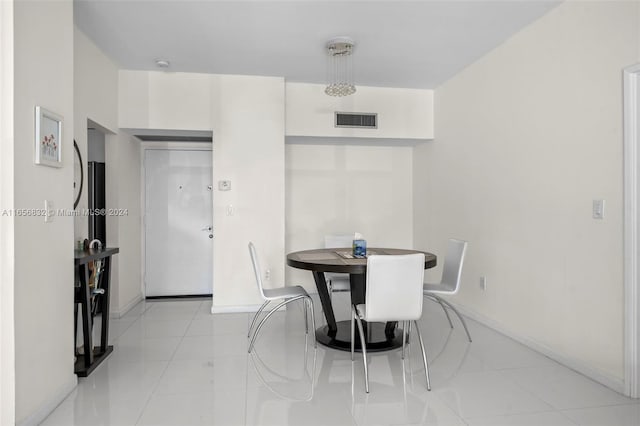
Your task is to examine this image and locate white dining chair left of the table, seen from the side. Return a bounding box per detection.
[247,242,318,352]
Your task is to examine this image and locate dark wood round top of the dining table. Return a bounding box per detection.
[287,247,436,274]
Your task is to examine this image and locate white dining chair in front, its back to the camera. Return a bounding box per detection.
[351,253,431,393]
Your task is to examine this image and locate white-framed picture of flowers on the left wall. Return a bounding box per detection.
[35,106,62,167]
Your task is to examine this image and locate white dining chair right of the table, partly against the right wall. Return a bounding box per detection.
[423,238,471,342]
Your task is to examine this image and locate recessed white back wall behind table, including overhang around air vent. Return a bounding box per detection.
[285,83,424,292]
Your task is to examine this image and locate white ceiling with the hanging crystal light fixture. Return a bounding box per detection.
[74,0,559,88]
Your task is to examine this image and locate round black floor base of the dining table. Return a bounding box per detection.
[316,320,402,352]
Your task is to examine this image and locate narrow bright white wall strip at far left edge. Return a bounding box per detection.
[0,1,15,425]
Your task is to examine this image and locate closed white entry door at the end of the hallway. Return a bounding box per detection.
[144,149,213,297]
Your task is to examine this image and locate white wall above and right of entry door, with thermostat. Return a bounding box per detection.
[119,70,284,310]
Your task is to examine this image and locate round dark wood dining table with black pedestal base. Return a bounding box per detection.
[287,247,437,352]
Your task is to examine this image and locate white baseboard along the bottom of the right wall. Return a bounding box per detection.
[448,300,625,395]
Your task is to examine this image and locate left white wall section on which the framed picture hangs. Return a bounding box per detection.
[13,1,76,424]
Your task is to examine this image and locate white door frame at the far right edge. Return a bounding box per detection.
[623,63,640,398]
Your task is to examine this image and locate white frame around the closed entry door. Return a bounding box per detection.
[140,141,215,299]
